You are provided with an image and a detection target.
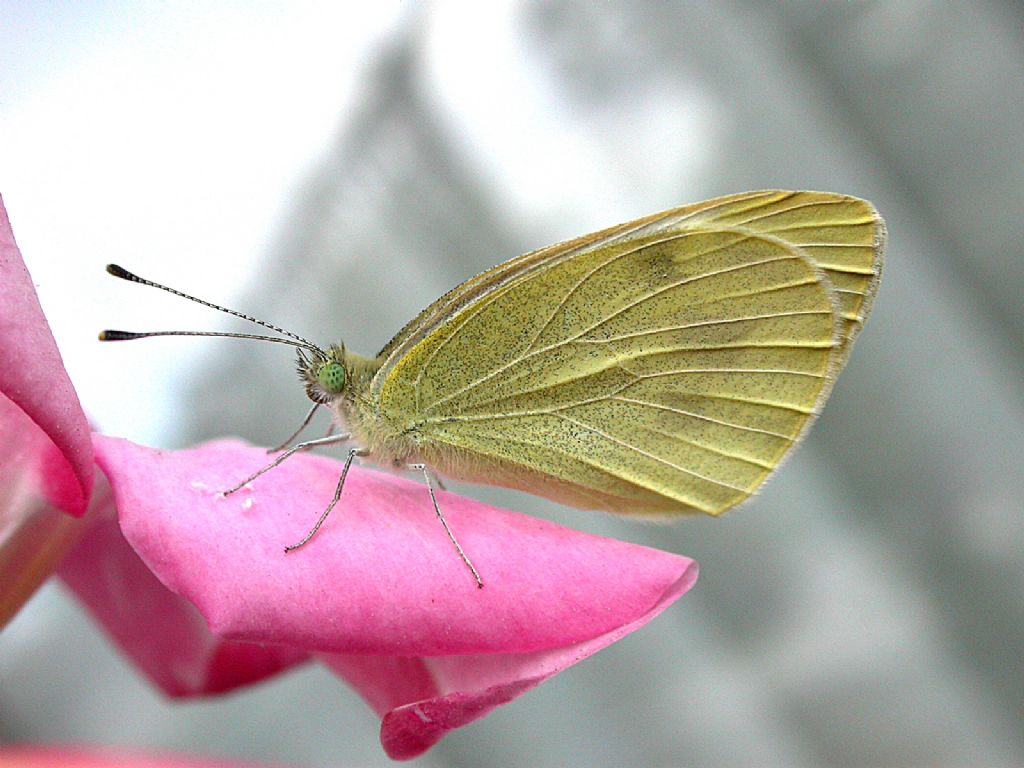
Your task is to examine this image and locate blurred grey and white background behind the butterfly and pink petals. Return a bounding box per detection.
[0,0,1024,768]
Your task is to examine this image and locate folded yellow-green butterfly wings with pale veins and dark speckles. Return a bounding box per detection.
[373,191,884,514]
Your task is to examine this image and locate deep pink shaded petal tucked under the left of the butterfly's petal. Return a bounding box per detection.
[60,475,309,696]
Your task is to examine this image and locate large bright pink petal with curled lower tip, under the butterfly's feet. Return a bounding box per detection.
[95,436,696,759]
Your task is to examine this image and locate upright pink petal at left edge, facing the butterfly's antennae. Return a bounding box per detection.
[0,193,93,516]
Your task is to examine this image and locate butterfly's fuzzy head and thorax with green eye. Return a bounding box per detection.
[299,345,417,465]
